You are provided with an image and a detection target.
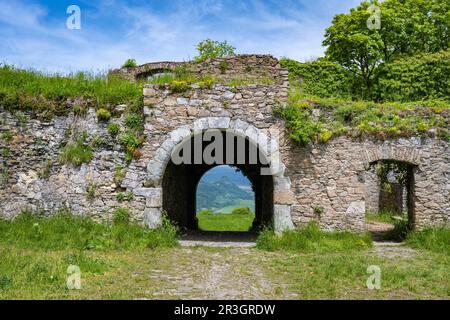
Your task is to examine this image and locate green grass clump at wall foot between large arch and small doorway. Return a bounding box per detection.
[256,222,372,252]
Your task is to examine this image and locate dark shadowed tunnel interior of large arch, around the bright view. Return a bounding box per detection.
[162,131,273,230]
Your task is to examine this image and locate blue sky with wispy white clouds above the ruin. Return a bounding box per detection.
[0,0,360,72]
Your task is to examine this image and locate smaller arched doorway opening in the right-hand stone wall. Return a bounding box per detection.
[365,159,417,240]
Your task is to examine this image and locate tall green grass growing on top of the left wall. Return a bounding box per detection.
[0,65,142,116]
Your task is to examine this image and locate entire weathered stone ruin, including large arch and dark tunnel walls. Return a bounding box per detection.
[0,55,450,230]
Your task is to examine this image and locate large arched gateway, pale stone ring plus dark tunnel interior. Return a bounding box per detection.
[147,117,293,231]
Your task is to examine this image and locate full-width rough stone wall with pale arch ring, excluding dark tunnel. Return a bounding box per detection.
[0,104,450,230]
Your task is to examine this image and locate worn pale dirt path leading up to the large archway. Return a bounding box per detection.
[146,248,282,299]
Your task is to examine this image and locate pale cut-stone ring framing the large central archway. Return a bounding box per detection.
[145,117,294,232]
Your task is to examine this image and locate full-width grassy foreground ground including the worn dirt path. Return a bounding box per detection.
[0,245,450,299]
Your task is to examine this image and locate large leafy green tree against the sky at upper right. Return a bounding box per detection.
[323,0,450,93]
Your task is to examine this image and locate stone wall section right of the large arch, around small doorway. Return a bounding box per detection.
[282,137,450,229]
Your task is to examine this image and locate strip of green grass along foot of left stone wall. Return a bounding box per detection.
[0,209,177,250]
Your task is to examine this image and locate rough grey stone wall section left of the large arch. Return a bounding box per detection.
[0,106,145,220]
